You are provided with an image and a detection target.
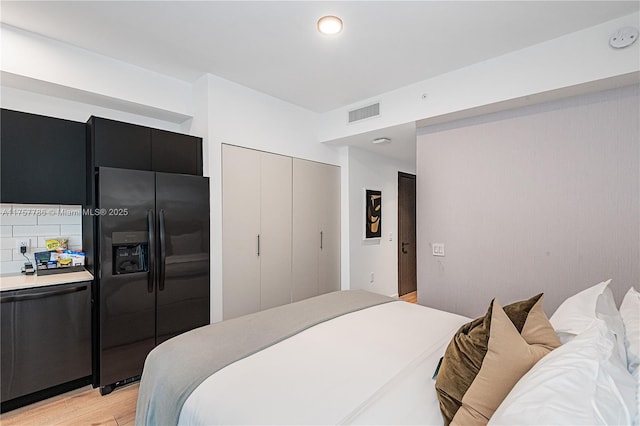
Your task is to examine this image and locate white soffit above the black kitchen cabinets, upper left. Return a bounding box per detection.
[0,24,191,123]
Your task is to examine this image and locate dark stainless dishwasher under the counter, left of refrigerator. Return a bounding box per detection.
[0,281,91,412]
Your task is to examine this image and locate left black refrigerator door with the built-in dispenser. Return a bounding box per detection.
[97,167,156,386]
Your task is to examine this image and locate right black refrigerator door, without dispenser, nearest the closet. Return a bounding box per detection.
[156,173,210,344]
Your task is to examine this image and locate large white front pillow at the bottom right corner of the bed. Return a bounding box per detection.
[489,320,637,425]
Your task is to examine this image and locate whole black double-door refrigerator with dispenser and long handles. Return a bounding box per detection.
[91,167,210,395]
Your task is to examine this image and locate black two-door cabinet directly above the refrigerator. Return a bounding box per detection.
[88,117,202,176]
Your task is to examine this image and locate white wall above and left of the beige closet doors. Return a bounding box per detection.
[193,75,348,321]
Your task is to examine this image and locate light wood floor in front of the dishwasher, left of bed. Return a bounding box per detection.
[0,383,139,426]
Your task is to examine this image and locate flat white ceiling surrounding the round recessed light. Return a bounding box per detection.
[0,0,640,112]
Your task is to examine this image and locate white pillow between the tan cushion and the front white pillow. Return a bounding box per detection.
[549,280,627,364]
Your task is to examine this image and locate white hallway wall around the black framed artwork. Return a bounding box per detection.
[343,147,415,296]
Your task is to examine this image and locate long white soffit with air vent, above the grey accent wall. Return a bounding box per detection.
[319,13,640,141]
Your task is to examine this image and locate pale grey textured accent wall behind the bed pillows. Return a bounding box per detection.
[417,85,640,317]
